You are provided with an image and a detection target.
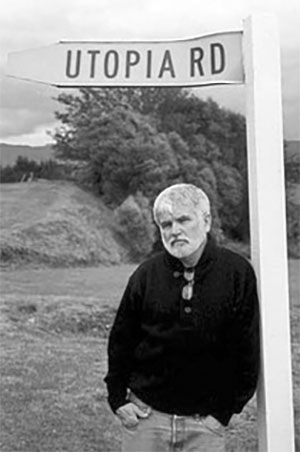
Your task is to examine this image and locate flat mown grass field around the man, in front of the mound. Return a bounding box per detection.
[0,260,300,451]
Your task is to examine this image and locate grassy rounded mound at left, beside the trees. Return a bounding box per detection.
[0,180,127,267]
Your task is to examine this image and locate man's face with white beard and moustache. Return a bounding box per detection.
[158,203,211,259]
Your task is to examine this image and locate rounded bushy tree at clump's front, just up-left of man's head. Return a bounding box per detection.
[77,107,178,205]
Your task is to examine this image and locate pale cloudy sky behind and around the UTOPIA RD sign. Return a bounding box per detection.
[0,0,300,146]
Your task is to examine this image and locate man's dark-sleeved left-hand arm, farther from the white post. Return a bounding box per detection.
[105,280,140,412]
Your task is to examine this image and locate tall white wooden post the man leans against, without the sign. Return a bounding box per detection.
[243,14,294,452]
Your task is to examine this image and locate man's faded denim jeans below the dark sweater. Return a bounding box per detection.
[122,396,225,452]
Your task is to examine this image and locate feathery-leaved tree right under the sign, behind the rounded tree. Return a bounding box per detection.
[54,87,186,160]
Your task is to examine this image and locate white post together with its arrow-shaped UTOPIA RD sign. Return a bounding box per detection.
[7,15,294,452]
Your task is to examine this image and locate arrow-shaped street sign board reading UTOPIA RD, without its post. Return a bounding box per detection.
[7,31,244,87]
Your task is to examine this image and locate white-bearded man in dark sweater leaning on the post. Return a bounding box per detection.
[105,184,259,451]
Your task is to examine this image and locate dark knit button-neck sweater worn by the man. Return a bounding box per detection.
[105,239,259,425]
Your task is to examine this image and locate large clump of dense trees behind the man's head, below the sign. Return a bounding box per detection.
[54,88,248,239]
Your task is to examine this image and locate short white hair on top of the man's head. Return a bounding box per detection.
[153,183,210,224]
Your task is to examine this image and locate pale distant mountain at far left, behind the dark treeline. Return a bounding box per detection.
[0,143,54,167]
